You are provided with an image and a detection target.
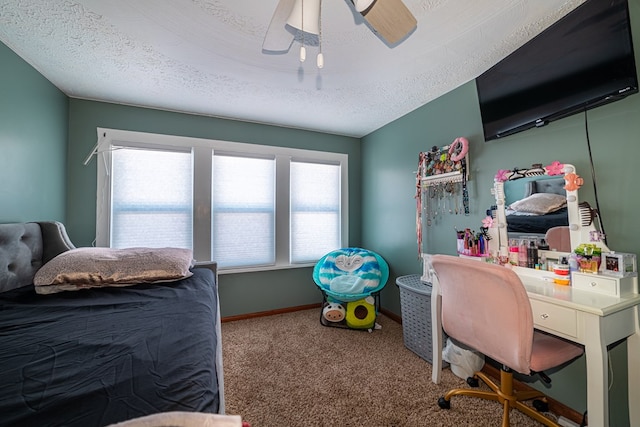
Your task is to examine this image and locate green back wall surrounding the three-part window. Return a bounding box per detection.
[66,99,361,316]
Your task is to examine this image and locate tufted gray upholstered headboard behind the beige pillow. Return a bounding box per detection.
[0,221,75,292]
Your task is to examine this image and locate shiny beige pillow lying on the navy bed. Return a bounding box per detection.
[33,248,194,294]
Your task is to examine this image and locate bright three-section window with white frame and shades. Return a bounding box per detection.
[96,128,348,272]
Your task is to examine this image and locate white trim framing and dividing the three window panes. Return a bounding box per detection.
[95,128,349,274]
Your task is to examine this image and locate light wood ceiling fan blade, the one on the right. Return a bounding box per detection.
[354,0,418,45]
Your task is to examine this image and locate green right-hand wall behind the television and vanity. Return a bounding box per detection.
[362,2,640,426]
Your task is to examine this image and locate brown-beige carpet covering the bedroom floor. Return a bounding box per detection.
[222,309,556,427]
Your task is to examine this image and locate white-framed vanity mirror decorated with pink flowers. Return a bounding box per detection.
[493,161,609,258]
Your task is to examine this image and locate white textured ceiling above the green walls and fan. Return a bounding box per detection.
[0,0,583,137]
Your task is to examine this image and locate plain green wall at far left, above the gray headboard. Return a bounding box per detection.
[0,43,68,223]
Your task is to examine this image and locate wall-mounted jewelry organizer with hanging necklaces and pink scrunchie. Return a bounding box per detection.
[416,137,469,253]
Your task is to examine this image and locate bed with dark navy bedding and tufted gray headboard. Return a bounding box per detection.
[0,222,224,426]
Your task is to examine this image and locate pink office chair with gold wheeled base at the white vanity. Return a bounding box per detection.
[432,255,584,427]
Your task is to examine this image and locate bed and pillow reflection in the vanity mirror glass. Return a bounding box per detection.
[505,176,569,235]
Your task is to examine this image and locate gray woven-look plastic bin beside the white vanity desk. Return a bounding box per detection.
[396,274,446,365]
